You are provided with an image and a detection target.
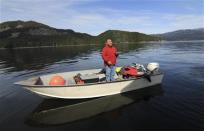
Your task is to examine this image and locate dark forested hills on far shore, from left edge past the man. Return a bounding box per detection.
[0,21,160,48]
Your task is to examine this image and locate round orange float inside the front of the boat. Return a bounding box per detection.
[49,76,65,86]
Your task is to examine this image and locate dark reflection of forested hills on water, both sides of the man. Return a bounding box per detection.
[0,44,151,73]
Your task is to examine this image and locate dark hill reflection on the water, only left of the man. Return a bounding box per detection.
[0,46,99,72]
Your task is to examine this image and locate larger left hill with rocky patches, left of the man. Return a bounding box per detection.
[0,21,92,48]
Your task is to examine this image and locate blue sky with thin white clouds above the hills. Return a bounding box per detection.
[0,0,204,35]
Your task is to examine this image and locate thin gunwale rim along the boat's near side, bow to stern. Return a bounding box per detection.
[14,72,164,88]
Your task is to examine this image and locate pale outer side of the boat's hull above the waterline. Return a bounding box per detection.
[18,74,163,99]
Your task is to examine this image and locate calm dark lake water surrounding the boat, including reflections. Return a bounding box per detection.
[0,41,204,131]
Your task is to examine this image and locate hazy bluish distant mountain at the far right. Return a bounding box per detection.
[154,28,204,41]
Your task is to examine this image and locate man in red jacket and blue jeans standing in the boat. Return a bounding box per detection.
[102,39,118,82]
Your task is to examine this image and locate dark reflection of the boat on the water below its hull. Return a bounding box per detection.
[26,85,163,126]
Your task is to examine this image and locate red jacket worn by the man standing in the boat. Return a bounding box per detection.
[102,45,117,65]
